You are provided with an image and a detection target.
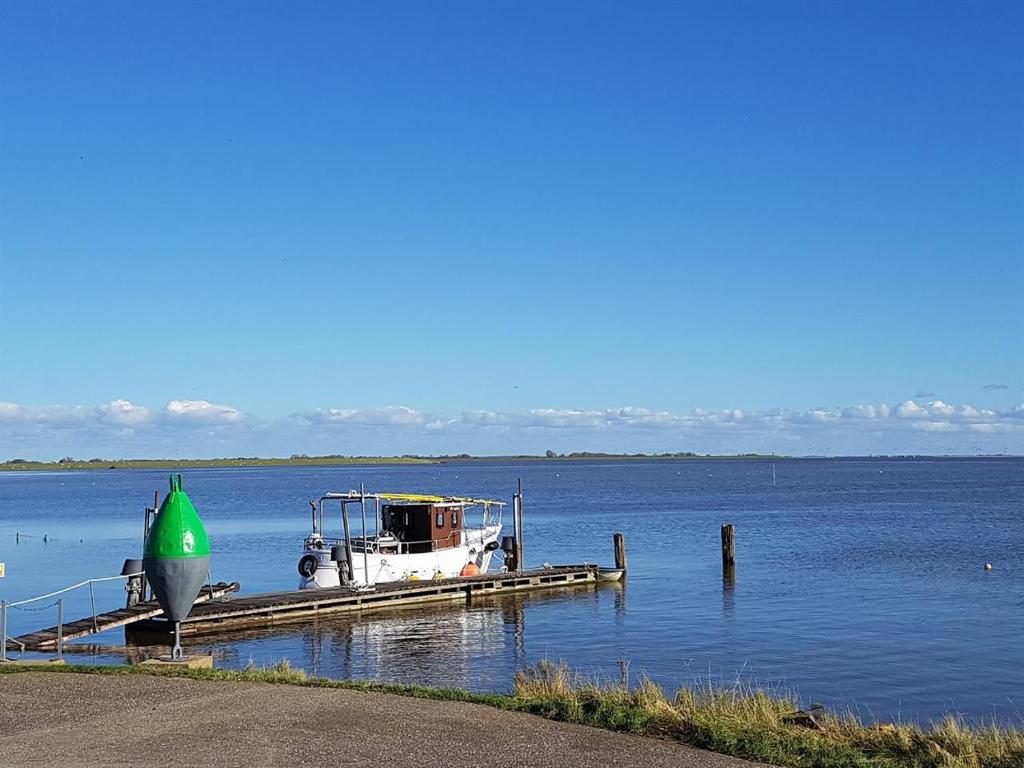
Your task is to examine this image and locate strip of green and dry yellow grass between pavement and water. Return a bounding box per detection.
[0,662,1024,768]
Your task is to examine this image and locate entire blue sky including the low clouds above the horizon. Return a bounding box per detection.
[0,0,1024,459]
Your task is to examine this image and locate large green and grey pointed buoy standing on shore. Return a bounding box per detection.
[142,474,210,660]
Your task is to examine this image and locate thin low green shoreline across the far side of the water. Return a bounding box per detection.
[0,452,1024,472]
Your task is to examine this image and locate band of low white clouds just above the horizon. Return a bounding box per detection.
[0,399,1024,459]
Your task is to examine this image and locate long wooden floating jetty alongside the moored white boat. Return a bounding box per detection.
[129,565,597,636]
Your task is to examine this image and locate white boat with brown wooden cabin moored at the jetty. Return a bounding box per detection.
[298,490,505,589]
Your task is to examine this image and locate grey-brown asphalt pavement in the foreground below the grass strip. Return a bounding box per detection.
[0,672,770,768]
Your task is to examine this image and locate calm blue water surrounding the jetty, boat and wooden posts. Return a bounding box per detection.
[0,460,1024,724]
